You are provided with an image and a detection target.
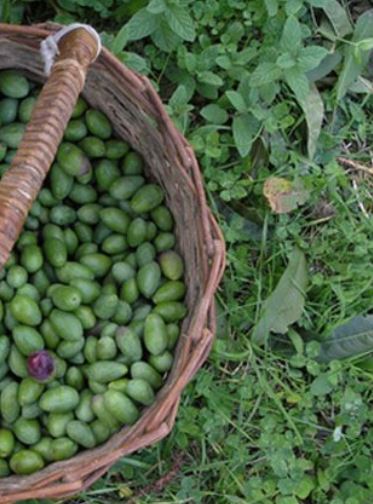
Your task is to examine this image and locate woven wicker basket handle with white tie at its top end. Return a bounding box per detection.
[0,25,101,270]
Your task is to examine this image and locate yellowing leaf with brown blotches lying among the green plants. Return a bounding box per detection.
[263,177,310,214]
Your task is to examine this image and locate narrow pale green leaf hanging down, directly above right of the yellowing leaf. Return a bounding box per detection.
[298,83,324,159]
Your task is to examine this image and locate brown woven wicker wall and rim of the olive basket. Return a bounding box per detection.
[0,24,225,504]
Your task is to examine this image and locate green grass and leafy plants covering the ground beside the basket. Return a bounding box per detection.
[0,0,373,504]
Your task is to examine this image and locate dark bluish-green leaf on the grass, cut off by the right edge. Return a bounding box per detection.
[318,315,373,362]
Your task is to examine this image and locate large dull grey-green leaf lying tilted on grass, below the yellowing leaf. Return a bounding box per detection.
[252,247,308,345]
